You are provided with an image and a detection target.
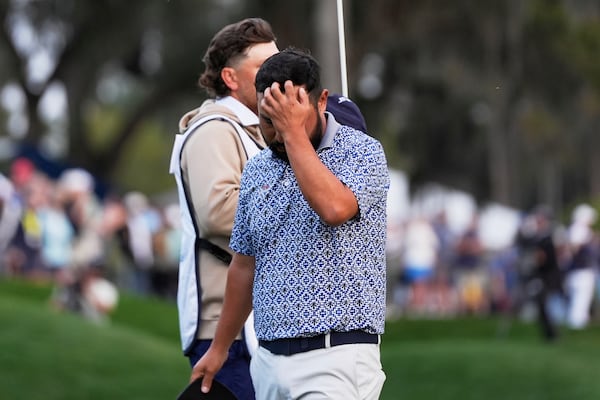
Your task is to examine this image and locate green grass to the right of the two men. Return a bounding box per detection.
[382,320,600,400]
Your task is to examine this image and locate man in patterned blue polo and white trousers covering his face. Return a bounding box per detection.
[191,49,389,400]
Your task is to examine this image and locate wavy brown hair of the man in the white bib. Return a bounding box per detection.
[198,18,276,96]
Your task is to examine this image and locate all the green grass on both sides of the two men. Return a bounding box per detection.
[0,280,600,400]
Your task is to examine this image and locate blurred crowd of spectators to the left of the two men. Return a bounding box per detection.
[0,158,179,319]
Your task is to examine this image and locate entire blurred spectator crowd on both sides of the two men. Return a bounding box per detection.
[0,158,600,339]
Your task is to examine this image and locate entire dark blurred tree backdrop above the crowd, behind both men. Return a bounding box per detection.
[0,0,600,209]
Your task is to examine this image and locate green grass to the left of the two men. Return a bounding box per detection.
[0,281,190,400]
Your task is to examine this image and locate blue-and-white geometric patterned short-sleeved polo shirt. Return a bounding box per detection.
[230,126,389,340]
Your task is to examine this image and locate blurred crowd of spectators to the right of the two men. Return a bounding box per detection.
[388,200,600,340]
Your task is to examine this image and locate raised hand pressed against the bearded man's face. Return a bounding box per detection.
[261,80,314,142]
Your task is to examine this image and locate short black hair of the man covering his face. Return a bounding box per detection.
[255,47,323,103]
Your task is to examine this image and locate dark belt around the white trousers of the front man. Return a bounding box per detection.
[258,331,379,356]
